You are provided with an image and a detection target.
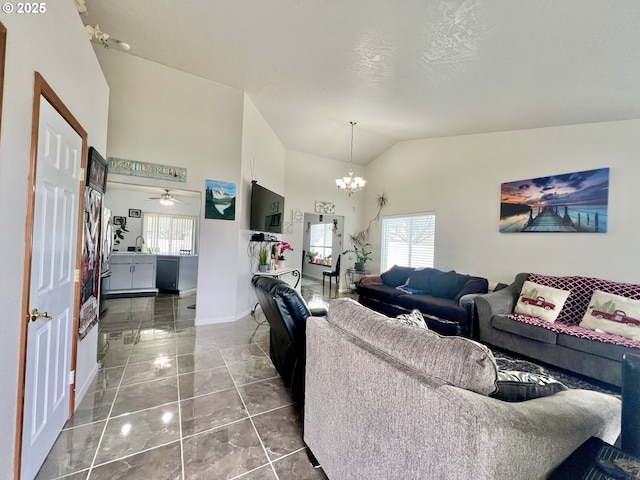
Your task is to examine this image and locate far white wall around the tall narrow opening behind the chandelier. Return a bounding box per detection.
[283,150,364,286]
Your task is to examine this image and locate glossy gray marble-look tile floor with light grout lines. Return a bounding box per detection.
[36,279,344,480]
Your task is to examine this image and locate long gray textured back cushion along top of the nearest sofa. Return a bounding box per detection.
[327,298,498,395]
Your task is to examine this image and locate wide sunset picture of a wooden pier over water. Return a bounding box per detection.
[500,168,609,233]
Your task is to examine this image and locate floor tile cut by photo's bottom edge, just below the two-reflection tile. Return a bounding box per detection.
[91,442,182,480]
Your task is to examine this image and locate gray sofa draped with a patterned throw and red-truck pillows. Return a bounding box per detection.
[475,273,640,387]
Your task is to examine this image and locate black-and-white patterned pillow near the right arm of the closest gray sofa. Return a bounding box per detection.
[489,371,567,402]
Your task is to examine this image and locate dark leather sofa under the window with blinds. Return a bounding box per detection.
[356,265,489,337]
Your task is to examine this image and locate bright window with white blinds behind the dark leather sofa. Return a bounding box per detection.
[380,212,436,272]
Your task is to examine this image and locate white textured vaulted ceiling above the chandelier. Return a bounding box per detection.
[81,0,640,164]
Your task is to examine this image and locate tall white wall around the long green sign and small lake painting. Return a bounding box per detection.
[96,47,244,324]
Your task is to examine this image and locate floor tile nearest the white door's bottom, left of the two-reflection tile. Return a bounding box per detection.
[36,421,106,480]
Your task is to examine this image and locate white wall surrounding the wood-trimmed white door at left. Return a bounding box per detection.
[0,1,109,475]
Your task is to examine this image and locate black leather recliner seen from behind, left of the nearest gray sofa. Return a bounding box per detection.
[251,275,327,402]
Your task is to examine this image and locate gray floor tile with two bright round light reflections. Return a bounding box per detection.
[96,403,180,464]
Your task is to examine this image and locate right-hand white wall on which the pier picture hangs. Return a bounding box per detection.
[366,120,640,282]
